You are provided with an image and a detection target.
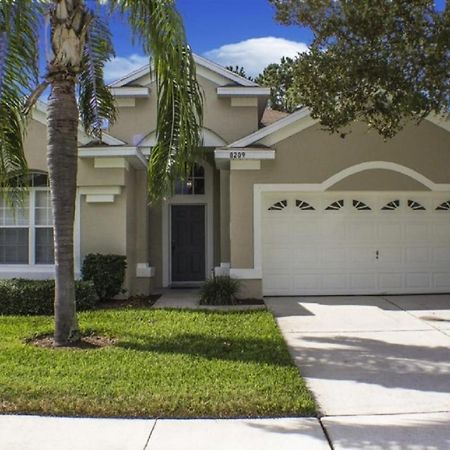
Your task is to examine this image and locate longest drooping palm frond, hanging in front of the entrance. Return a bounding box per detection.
[112,0,203,199]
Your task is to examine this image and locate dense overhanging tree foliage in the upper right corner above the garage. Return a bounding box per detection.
[269,0,450,138]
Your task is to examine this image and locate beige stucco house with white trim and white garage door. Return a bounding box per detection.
[0,57,450,297]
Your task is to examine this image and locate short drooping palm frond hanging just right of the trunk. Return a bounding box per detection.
[78,15,116,139]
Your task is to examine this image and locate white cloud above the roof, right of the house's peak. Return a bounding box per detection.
[204,36,308,76]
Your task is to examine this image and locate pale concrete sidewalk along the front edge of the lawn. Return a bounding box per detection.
[0,416,330,450]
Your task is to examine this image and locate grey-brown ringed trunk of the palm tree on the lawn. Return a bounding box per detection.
[47,75,80,346]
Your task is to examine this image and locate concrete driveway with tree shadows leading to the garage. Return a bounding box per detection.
[266,295,450,450]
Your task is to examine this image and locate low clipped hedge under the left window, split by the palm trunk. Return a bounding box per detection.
[0,279,98,316]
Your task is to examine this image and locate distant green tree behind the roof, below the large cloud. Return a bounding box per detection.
[255,57,298,112]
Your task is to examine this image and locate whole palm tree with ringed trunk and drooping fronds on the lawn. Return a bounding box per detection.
[0,0,202,346]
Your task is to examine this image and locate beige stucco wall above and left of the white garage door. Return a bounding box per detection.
[230,121,450,268]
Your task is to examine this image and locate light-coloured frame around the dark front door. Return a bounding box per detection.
[162,161,214,287]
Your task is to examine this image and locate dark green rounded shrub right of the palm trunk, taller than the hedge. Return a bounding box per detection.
[81,253,127,301]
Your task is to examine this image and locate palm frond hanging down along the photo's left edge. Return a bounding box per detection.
[0,0,42,195]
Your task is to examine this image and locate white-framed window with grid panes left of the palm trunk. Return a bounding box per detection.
[0,173,54,265]
